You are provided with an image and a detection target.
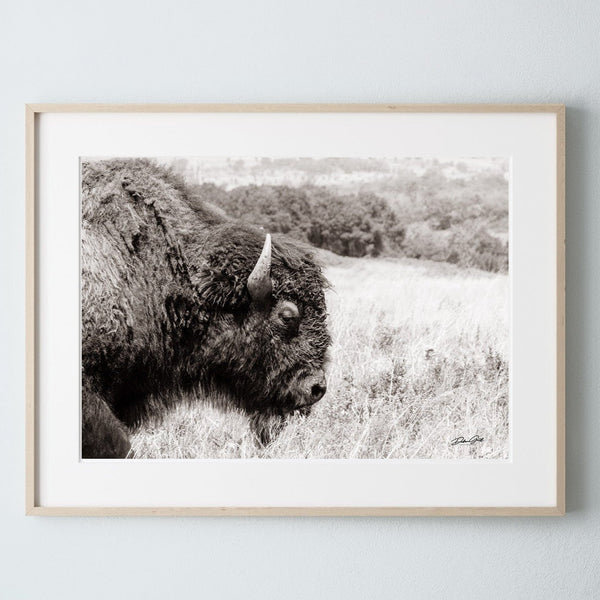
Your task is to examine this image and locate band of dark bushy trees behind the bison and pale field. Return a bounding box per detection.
[188,176,508,272]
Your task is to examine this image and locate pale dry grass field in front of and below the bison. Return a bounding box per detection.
[132,254,509,459]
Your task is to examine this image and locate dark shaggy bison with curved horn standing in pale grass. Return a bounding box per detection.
[81,159,330,458]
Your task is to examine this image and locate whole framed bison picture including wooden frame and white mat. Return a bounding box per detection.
[26,104,565,516]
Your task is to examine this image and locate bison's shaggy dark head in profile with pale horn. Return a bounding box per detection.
[191,224,330,426]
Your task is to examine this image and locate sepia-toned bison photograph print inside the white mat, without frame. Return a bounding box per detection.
[80,156,510,460]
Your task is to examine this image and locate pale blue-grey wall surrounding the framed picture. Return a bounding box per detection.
[0,0,600,600]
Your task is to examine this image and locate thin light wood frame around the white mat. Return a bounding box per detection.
[25,103,566,517]
